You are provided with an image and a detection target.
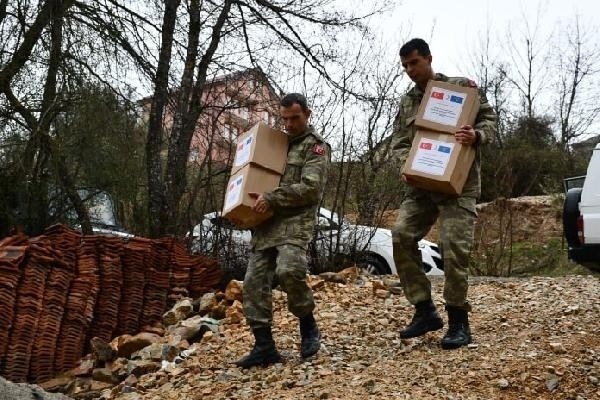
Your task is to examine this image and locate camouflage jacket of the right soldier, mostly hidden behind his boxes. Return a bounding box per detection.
[391,74,496,198]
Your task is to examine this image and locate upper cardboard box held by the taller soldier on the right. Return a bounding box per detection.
[415,80,479,133]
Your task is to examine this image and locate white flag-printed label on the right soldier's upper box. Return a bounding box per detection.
[423,87,467,126]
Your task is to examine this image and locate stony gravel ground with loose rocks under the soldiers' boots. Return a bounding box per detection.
[31,269,600,400]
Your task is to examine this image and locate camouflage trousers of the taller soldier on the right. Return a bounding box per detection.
[392,191,477,311]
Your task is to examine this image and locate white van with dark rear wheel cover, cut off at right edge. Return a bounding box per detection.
[563,144,600,270]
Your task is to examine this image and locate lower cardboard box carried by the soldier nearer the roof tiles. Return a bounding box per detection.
[222,164,281,228]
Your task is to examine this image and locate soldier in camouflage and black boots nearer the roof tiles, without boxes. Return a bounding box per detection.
[236,93,331,368]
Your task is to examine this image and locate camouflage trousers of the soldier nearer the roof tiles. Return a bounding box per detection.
[244,244,315,329]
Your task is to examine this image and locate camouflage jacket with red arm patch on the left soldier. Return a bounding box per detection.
[251,126,331,250]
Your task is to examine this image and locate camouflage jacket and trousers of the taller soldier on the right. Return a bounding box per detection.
[392,74,496,311]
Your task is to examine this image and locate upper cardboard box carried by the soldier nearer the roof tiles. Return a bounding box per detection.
[231,122,288,174]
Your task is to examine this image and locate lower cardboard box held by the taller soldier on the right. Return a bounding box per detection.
[402,130,475,195]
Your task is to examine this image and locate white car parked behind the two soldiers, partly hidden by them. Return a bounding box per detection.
[191,208,444,279]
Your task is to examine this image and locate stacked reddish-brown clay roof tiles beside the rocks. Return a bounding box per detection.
[0,225,221,382]
